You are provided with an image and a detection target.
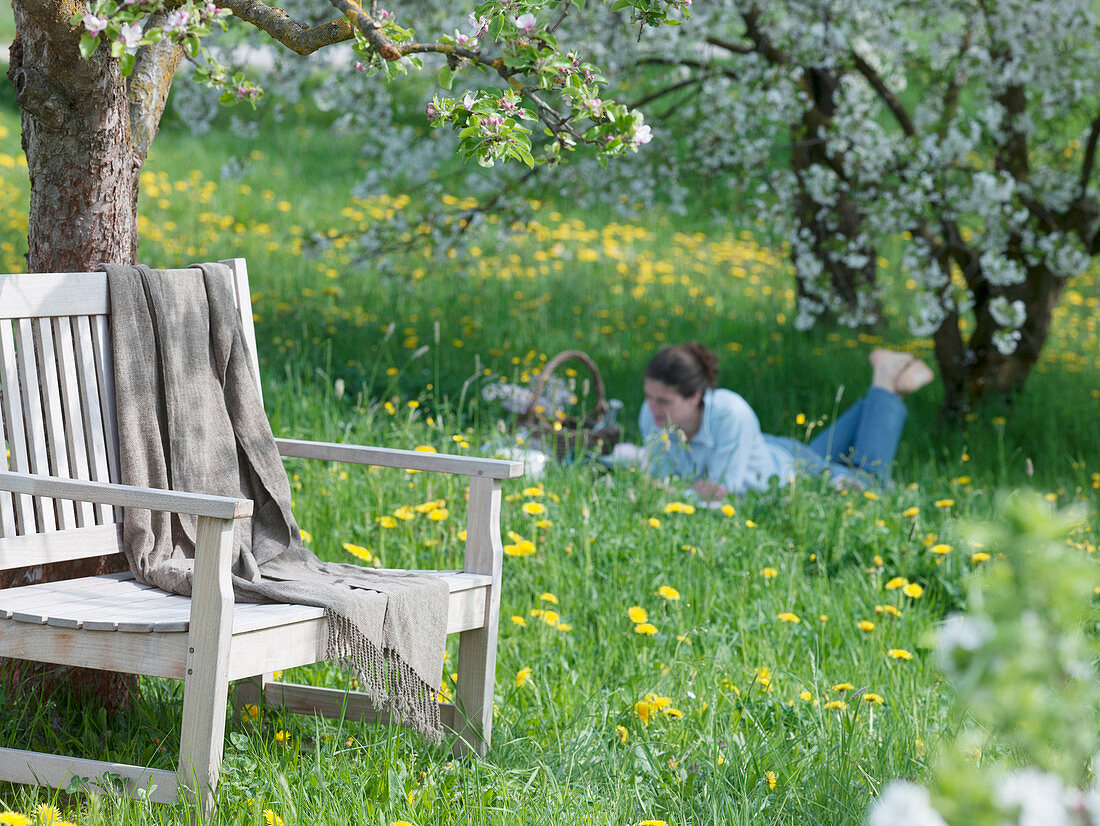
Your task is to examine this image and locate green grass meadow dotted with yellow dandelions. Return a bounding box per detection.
[0,53,1100,826]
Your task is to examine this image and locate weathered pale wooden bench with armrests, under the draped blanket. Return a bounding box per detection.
[0,258,523,813]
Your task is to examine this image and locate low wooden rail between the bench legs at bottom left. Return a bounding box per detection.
[0,749,179,803]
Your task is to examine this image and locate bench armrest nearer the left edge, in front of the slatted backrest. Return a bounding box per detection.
[0,471,252,519]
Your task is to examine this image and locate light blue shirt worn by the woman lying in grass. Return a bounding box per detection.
[638,388,794,496]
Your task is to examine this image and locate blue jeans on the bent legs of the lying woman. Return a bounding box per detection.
[771,387,909,484]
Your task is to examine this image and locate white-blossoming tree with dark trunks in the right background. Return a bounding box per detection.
[572,0,1100,410]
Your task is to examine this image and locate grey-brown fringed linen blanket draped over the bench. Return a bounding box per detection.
[101,264,449,740]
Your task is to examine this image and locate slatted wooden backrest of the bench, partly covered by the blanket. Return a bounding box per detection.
[0,258,259,570]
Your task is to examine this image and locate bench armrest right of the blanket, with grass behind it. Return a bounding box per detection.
[275,439,524,480]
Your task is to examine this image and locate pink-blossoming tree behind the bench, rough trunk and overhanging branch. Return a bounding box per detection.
[7,0,660,704]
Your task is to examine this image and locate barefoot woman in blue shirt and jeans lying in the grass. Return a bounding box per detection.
[638,342,933,499]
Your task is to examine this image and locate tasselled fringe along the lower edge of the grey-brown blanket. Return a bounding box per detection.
[325,608,443,744]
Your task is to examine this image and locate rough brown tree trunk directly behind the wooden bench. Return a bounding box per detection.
[0,0,179,709]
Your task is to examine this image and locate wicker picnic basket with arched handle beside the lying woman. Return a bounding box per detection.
[516,350,622,462]
